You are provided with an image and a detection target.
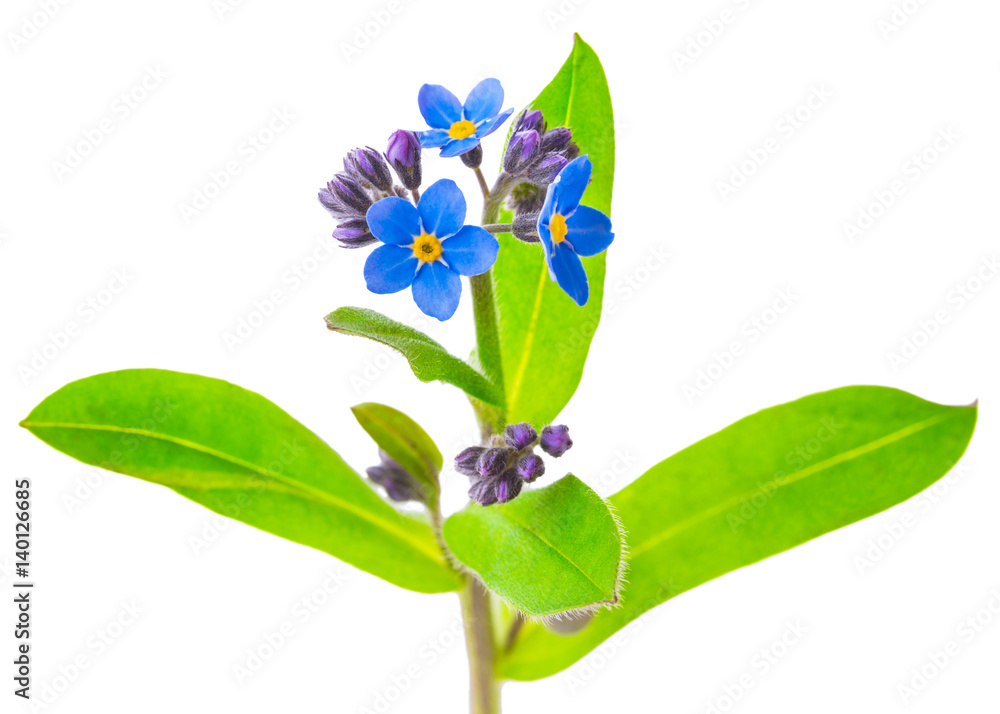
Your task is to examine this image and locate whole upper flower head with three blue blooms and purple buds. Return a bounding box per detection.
[319,73,614,320]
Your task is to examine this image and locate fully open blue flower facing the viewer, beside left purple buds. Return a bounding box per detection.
[365,179,500,320]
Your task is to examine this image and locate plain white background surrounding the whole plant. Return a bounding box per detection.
[0,0,1000,714]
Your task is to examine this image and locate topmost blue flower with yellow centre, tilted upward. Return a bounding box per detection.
[417,79,514,156]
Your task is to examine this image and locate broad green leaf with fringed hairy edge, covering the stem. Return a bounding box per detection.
[444,475,622,616]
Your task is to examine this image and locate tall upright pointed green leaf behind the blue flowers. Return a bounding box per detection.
[493,35,615,427]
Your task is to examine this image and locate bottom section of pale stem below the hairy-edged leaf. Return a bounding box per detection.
[459,575,500,714]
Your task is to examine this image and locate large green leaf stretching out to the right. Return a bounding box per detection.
[499,387,976,680]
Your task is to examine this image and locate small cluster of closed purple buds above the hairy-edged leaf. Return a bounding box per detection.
[455,422,573,506]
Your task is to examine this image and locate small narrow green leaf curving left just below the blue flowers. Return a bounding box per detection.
[326,307,503,405]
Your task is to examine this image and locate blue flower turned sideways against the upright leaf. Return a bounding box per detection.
[538,154,615,305]
